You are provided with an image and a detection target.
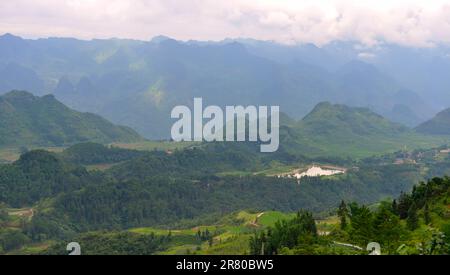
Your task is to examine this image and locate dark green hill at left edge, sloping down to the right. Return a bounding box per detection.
[0,91,141,147]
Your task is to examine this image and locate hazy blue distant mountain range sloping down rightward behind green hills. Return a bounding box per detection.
[0,35,440,138]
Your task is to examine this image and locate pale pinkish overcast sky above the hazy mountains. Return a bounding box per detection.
[0,0,450,47]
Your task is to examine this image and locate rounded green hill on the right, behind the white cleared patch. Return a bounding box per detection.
[280,102,447,157]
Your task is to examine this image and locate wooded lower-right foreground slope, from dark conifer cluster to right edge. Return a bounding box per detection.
[250,178,450,255]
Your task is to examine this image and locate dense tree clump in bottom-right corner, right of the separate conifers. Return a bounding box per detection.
[347,178,450,255]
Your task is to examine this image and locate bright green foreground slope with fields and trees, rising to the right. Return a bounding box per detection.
[14,178,450,255]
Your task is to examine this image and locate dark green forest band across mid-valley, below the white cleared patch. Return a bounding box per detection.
[0,144,428,241]
